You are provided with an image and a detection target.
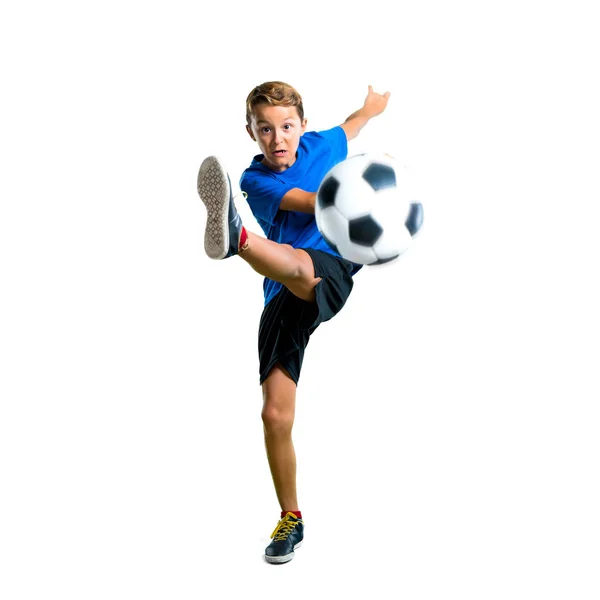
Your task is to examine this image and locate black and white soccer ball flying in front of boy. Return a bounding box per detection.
[315,153,423,265]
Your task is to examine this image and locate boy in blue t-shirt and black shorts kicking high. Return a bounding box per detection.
[198,81,390,563]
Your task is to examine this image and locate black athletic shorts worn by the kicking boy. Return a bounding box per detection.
[258,248,360,385]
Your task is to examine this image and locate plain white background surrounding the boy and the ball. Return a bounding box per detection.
[0,0,600,600]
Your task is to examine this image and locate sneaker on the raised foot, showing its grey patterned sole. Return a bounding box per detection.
[198,156,244,260]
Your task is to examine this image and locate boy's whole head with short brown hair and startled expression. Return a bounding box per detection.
[246,81,306,171]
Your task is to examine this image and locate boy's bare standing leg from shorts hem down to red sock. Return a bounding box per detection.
[262,365,298,511]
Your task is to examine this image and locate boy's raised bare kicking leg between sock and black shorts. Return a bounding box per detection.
[239,231,321,302]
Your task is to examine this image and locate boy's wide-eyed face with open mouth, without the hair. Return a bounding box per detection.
[246,104,306,171]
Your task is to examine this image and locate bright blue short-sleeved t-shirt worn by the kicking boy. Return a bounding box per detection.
[240,125,348,306]
